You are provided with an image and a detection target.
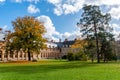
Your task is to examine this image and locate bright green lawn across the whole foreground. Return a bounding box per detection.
[0,60,120,80]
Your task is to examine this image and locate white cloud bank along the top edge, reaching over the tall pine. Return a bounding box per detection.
[47,0,120,18]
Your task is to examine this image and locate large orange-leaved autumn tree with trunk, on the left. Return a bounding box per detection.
[6,16,46,61]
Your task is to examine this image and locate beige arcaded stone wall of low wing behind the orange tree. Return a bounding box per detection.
[0,48,60,61]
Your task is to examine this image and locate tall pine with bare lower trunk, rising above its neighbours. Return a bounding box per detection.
[77,5,111,63]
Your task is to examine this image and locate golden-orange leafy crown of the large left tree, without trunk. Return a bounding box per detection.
[9,16,46,49]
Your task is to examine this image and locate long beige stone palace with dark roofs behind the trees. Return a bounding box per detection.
[0,34,80,61]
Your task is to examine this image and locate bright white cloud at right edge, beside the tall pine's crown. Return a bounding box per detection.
[109,6,120,20]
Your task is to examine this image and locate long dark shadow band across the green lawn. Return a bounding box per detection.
[0,61,95,75]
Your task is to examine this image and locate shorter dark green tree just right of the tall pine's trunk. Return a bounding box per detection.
[98,30,116,62]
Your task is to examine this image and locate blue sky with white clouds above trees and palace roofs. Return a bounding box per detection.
[0,0,120,41]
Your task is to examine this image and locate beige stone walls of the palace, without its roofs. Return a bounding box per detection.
[0,41,80,61]
